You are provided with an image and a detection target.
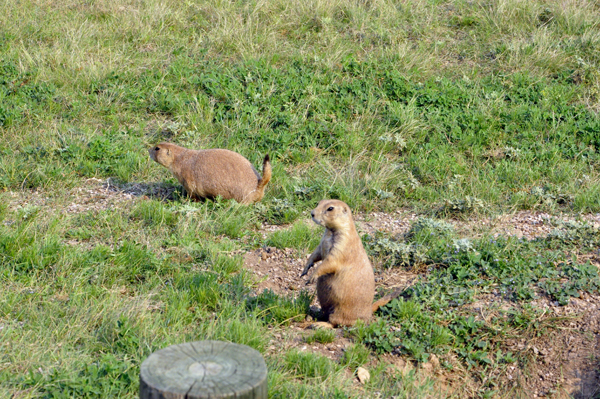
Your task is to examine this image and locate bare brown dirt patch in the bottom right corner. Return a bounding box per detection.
[492,293,600,399]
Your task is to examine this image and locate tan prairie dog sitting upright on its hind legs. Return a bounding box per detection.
[301,200,400,327]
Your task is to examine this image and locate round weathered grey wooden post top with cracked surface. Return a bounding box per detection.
[140,341,267,399]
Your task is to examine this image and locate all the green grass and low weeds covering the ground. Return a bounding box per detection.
[0,0,600,399]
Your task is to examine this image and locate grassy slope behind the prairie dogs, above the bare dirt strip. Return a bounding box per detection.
[0,2,600,216]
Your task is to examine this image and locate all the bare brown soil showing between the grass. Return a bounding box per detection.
[5,179,600,399]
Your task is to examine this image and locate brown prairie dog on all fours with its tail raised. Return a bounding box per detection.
[148,143,271,204]
